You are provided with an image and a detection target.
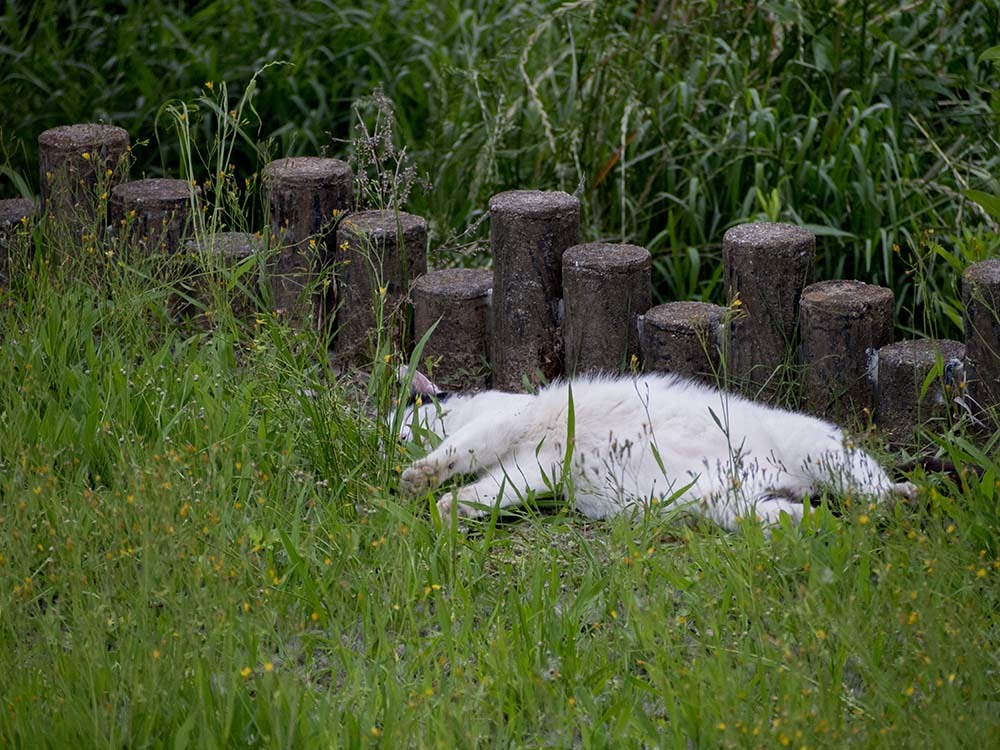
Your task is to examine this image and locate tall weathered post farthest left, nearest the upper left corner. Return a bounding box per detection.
[38,124,130,226]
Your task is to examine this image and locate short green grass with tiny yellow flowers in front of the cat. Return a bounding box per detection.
[0,212,1000,748]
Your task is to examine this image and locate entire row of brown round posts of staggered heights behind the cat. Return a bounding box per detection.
[0,125,1000,441]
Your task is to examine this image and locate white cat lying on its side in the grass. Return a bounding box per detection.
[401,373,915,529]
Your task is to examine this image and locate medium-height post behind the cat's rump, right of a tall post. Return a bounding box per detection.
[799,281,894,423]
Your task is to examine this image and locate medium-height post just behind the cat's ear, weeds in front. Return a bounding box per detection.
[334,211,427,366]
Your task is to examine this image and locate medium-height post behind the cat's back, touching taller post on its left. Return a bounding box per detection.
[562,242,651,375]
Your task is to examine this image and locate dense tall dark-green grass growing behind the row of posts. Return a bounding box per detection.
[0,0,1000,334]
